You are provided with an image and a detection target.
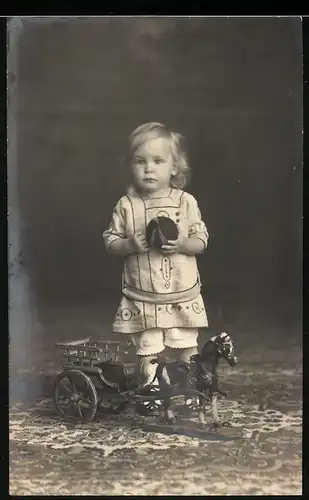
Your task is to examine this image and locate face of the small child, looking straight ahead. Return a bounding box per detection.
[132,137,176,194]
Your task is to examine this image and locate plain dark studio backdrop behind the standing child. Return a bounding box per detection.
[16,18,302,334]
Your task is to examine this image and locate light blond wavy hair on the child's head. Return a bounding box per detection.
[130,122,191,189]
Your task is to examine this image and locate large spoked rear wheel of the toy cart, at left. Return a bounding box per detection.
[53,369,98,423]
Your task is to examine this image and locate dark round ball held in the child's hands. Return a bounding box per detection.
[146,216,178,250]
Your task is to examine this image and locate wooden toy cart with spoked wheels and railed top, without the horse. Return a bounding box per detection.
[53,337,160,423]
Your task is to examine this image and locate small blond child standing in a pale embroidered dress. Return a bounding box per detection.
[103,123,208,385]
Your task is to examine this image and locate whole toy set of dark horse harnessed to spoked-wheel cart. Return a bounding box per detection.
[53,333,237,423]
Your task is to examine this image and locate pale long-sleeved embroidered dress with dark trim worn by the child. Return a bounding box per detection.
[103,188,208,334]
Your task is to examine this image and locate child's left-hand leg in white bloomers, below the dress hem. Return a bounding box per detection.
[131,328,165,385]
